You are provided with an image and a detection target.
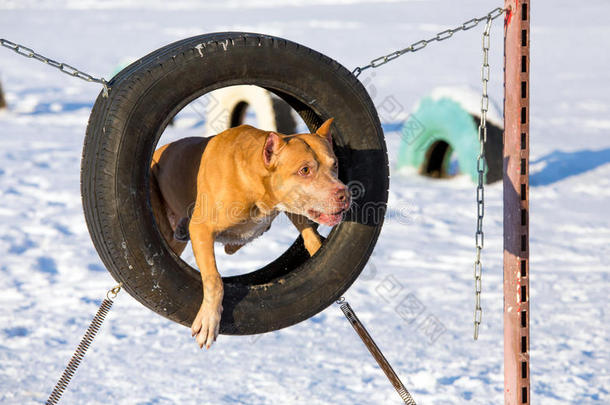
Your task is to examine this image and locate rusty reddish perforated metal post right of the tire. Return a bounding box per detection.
[504,0,531,405]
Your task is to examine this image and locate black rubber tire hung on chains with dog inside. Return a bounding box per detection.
[81,33,389,334]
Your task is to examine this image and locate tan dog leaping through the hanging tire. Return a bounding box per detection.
[150,118,350,349]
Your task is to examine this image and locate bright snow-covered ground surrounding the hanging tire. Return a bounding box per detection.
[0,0,610,405]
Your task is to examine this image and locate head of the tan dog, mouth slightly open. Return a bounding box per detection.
[262,118,351,226]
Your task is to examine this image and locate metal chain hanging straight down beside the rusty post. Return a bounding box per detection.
[474,17,493,340]
